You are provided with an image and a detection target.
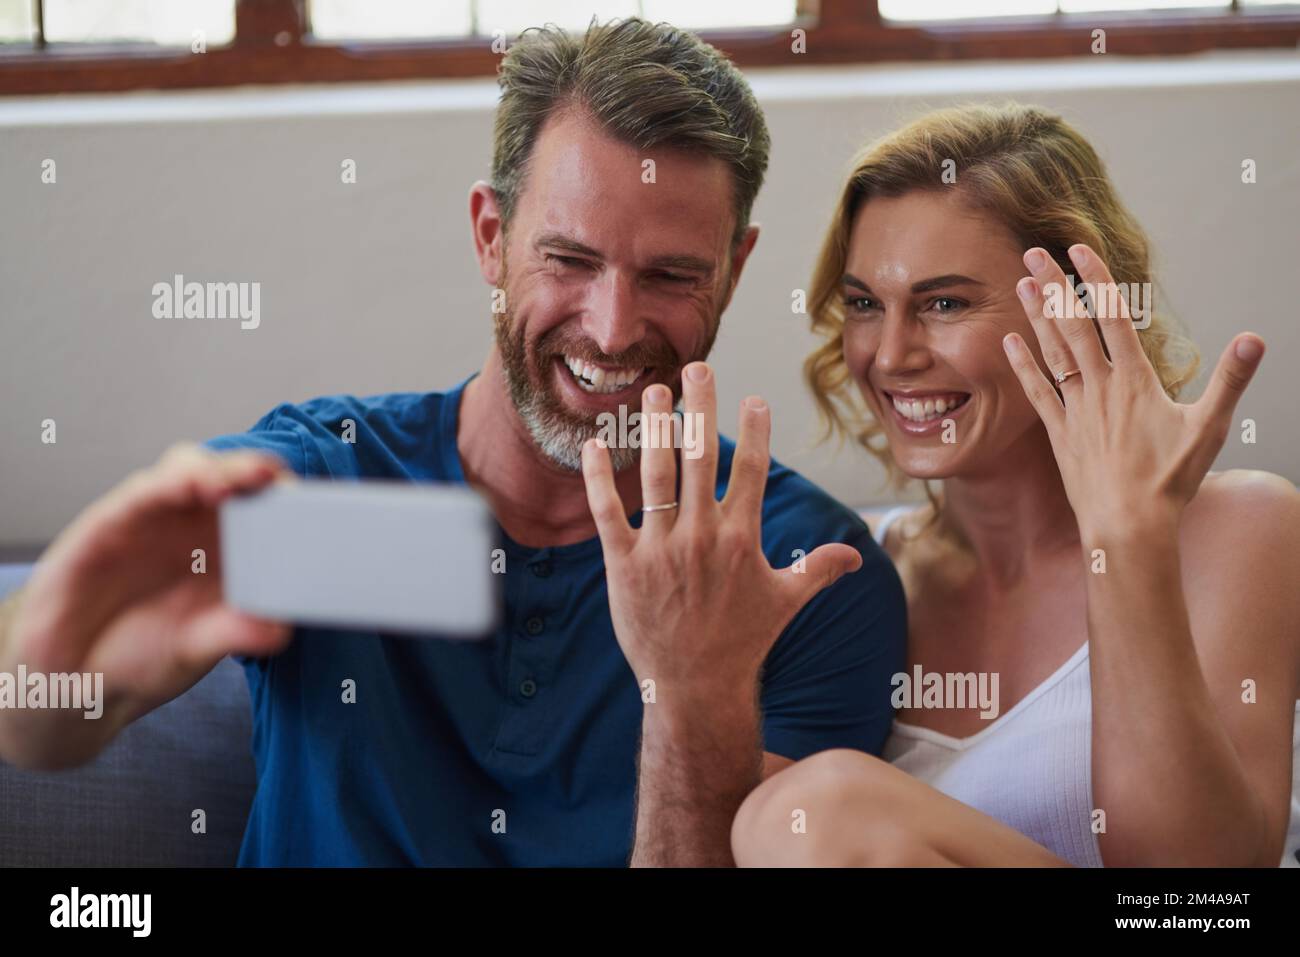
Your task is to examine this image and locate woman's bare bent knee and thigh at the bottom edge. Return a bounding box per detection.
[732,749,1069,867]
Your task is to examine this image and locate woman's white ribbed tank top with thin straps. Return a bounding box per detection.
[876,506,1300,867]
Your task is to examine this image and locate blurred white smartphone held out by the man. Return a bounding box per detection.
[218,479,501,638]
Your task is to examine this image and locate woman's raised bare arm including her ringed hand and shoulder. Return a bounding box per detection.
[1005,244,1300,866]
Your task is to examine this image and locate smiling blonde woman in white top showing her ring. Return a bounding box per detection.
[732,107,1300,866]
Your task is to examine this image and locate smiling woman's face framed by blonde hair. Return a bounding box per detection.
[840,191,1041,479]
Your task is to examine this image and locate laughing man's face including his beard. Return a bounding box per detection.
[488,111,757,471]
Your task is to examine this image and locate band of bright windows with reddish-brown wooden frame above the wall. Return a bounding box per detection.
[0,0,1300,95]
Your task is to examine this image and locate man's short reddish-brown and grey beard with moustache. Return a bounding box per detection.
[493,265,718,472]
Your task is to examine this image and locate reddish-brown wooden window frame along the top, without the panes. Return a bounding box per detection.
[0,0,1300,96]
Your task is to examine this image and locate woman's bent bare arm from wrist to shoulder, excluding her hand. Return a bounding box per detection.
[1088,473,1300,866]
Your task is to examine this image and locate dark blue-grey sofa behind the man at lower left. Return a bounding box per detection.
[0,564,256,867]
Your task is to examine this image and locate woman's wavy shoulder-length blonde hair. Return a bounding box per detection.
[803,103,1200,515]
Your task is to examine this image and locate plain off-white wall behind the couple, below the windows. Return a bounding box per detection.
[0,53,1300,546]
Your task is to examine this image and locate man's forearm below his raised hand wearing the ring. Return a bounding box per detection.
[632,683,763,867]
